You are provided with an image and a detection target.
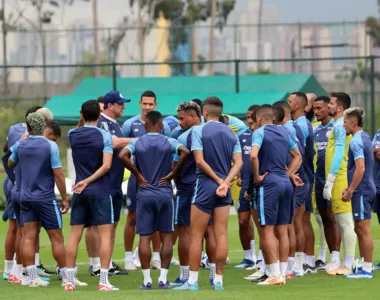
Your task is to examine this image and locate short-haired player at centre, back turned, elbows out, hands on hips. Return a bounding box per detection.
[119,111,189,290]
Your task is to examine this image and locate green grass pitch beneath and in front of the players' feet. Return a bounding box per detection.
[0,216,380,300]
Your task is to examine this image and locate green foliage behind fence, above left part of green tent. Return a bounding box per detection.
[71,51,112,83]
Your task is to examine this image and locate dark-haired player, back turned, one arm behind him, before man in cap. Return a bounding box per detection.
[65,98,118,292]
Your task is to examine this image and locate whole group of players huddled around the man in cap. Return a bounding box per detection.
[3,91,380,291]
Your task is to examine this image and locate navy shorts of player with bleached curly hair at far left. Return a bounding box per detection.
[21,200,62,230]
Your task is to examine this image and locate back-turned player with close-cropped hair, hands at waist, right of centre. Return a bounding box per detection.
[250,105,302,285]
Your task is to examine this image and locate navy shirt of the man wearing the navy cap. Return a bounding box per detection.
[98,114,124,195]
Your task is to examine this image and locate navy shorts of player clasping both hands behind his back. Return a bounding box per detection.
[192,177,232,215]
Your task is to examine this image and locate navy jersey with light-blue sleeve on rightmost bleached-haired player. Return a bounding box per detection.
[347,130,376,195]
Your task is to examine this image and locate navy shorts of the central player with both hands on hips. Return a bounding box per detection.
[136,196,174,236]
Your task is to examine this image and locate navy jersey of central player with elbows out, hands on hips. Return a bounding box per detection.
[126,133,181,198]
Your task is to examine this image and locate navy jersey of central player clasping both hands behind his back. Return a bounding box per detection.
[191,121,241,179]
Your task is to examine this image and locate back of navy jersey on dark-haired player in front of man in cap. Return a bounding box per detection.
[68,125,113,195]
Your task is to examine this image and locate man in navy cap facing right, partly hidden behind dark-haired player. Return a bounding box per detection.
[85,91,131,276]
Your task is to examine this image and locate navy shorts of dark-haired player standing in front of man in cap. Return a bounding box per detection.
[70,194,115,227]
